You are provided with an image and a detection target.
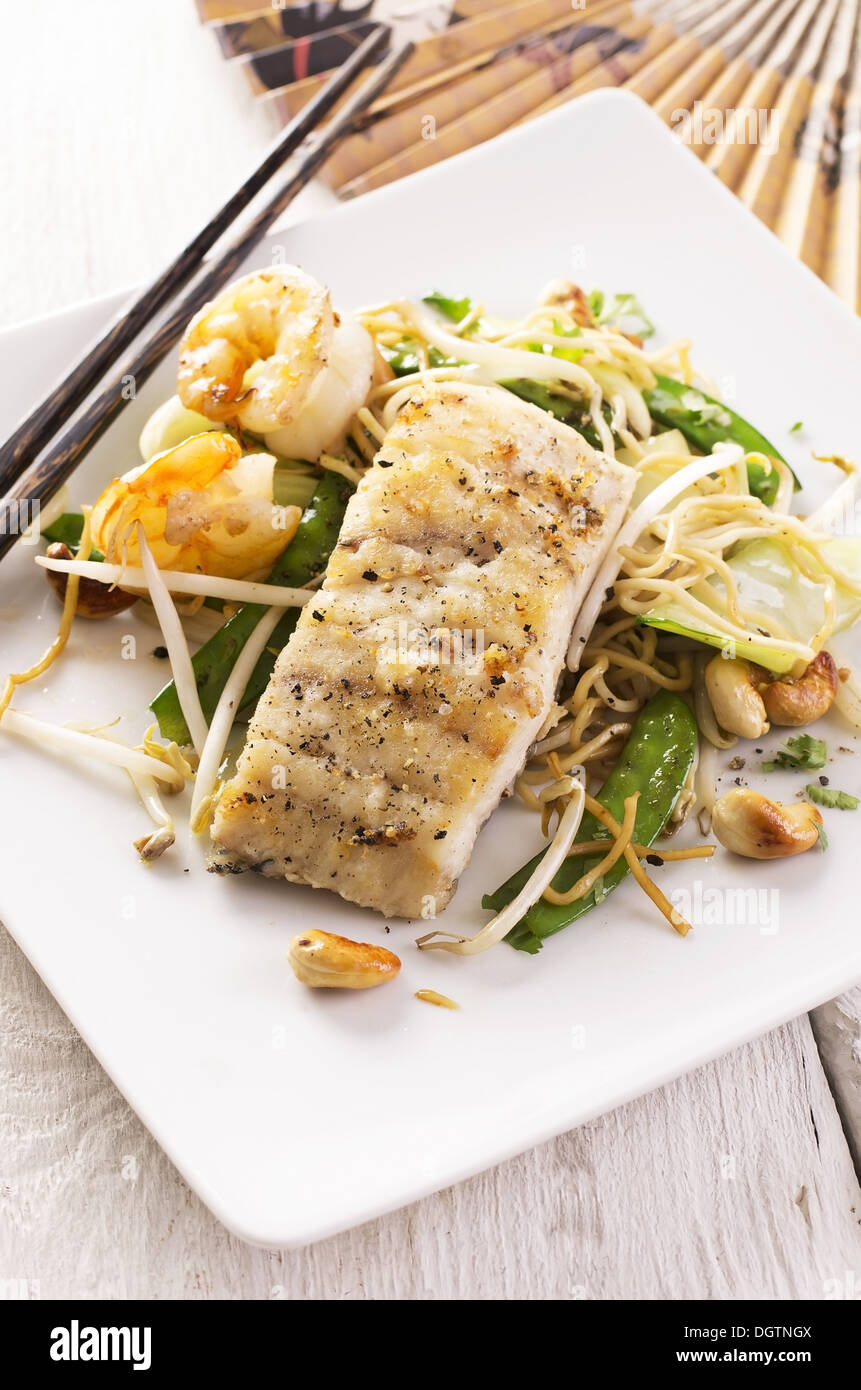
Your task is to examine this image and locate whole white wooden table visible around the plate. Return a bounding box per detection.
[0,0,861,1298]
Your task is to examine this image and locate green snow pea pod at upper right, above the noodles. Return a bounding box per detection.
[643,374,800,507]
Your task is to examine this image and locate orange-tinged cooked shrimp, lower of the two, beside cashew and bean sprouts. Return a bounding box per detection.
[92,432,302,580]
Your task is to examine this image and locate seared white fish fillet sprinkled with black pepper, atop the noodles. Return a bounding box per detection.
[211,384,633,917]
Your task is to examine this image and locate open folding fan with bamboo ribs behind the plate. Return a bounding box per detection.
[196,0,861,311]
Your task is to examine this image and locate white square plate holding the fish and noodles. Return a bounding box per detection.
[0,93,861,1245]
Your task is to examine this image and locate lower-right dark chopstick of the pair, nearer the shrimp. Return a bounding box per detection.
[0,43,415,559]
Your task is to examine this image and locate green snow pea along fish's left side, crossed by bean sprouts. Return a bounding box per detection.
[150,473,352,744]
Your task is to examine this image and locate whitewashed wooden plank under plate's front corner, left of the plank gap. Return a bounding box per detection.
[0,917,861,1298]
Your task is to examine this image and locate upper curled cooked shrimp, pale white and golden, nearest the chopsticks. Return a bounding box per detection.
[177,265,374,460]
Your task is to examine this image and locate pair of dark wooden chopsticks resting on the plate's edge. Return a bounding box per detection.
[0,25,413,559]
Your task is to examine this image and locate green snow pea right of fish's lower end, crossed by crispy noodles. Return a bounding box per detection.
[481,691,697,954]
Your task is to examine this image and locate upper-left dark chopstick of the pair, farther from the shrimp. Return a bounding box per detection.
[0,25,391,496]
